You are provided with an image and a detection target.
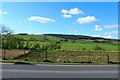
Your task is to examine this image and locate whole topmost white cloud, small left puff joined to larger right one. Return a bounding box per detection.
[61,8,84,14]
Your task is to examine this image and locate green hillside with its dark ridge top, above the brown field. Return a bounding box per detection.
[3,34,119,51]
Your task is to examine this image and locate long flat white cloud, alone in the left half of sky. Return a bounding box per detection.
[28,16,55,23]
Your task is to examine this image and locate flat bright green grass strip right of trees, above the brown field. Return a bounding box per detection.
[61,42,118,51]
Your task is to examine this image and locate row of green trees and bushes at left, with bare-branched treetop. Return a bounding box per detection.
[0,25,61,60]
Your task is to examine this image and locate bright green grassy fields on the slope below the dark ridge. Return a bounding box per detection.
[3,35,119,51]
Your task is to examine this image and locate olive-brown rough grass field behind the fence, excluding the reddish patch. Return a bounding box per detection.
[12,51,118,63]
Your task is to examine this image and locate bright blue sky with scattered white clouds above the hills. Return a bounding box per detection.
[0,2,118,39]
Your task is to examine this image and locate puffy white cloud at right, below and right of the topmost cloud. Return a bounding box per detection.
[76,16,98,24]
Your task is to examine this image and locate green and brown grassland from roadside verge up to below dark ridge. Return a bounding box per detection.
[3,35,118,65]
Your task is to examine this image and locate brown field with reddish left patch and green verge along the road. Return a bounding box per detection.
[2,50,118,65]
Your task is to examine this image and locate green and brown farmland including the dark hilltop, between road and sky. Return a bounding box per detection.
[3,34,119,64]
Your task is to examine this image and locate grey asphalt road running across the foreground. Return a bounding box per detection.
[2,63,118,78]
